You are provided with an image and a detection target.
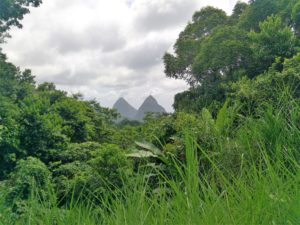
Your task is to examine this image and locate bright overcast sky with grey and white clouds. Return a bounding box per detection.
[3,0,246,111]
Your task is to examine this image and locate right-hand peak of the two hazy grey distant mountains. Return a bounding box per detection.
[135,95,166,120]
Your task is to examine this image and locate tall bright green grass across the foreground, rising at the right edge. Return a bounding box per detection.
[0,104,300,225]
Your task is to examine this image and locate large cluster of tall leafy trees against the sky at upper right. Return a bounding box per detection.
[164,0,299,112]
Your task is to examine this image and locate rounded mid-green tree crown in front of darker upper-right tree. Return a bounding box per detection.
[193,26,252,81]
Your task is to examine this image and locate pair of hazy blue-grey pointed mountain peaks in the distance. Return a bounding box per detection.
[113,95,166,121]
